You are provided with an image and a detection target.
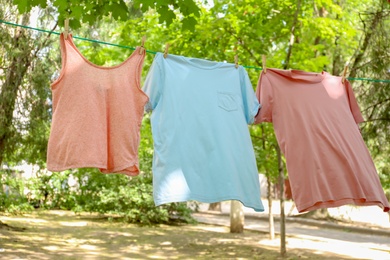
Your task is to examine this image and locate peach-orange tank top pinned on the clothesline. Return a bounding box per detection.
[47,34,148,176]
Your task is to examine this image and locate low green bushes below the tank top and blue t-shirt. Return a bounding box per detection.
[21,169,194,224]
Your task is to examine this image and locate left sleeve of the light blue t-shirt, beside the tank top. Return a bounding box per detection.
[142,53,164,112]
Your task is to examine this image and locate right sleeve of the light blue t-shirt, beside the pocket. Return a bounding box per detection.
[240,67,261,124]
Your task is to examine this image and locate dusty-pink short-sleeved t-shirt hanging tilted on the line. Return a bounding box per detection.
[256,69,389,212]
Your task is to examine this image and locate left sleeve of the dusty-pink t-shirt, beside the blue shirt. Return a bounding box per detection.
[255,71,273,124]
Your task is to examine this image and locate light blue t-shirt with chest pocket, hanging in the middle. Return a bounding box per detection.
[143,53,264,211]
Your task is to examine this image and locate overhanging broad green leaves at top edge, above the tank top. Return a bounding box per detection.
[13,0,200,30]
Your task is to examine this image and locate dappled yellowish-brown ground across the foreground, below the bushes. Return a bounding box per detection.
[0,211,350,260]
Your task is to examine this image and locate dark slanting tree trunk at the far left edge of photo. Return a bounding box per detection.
[0,14,32,165]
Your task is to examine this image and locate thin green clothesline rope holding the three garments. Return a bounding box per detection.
[0,19,390,83]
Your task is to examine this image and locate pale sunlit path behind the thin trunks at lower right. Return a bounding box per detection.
[194,212,390,260]
